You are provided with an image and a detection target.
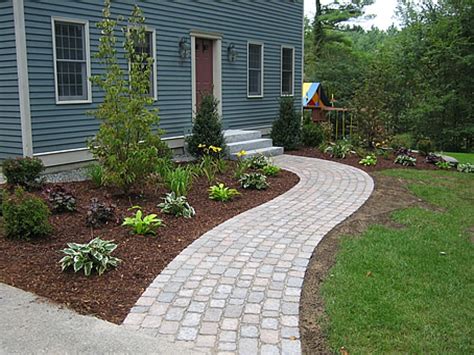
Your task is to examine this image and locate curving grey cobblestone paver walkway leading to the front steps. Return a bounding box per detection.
[123,155,373,355]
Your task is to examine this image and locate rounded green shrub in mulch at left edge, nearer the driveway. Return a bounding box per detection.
[2,188,53,240]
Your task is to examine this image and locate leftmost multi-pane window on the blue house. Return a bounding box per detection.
[52,18,92,104]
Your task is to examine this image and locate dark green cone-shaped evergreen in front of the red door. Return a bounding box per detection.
[186,95,225,157]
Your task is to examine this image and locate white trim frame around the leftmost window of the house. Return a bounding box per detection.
[51,16,92,105]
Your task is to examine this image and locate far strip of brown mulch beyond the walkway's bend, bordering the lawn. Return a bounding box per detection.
[285,147,438,173]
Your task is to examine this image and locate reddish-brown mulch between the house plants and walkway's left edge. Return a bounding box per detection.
[0,165,299,323]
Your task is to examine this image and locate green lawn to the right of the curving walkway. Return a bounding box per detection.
[322,170,474,354]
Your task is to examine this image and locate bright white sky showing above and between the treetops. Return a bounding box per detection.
[304,0,397,30]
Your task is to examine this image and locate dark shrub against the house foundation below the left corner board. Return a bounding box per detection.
[2,157,44,189]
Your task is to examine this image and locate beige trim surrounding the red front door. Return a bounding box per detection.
[189,30,222,118]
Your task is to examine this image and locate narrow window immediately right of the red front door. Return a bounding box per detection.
[247,42,263,97]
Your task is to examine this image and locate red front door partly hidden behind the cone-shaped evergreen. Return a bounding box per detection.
[196,38,213,110]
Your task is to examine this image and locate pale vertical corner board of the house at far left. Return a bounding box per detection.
[13,0,33,157]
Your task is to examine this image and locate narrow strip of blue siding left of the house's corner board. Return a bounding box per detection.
[0,1,23,160]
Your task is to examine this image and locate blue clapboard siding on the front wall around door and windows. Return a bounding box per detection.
[25,0,303,153]
